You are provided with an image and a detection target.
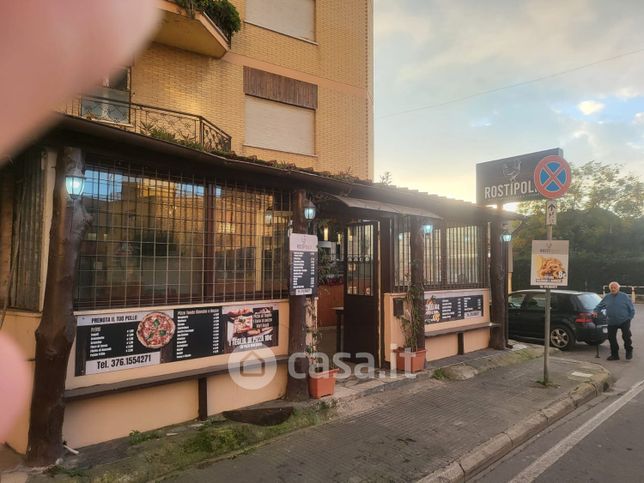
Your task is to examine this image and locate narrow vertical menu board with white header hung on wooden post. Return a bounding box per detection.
[289,233,318,295]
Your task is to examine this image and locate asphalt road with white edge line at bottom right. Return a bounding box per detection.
[472,304,644,483]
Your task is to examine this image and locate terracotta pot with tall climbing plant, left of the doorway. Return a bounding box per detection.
[306,300,338,399]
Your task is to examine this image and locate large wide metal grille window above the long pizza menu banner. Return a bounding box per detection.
[75,163,291,309]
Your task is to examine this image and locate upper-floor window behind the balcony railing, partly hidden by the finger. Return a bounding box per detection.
[81,67,130,124]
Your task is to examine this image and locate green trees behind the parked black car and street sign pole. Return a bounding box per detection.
[512,161,644,291]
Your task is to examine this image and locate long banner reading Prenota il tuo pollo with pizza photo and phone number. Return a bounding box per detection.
[75,304,279,376]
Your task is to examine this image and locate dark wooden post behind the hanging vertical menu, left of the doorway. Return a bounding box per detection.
[286,190,309,401]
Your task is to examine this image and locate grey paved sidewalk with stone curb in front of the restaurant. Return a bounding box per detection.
[2,345,609,482]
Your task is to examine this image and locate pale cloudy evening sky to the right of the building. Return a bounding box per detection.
[374,0,644,201]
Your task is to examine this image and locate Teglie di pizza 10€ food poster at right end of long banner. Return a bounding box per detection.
[222,305,279,352]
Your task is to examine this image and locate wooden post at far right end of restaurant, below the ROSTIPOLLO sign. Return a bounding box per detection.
[490,209,506,350]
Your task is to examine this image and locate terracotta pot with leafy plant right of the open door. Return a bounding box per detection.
[394,286,427,372]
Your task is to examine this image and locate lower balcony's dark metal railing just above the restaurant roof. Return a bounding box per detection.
[63,96,231,152]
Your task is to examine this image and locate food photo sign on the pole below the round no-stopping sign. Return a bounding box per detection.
[530,240,568,288]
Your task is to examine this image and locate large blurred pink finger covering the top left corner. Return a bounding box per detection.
[0,0,160,157]
